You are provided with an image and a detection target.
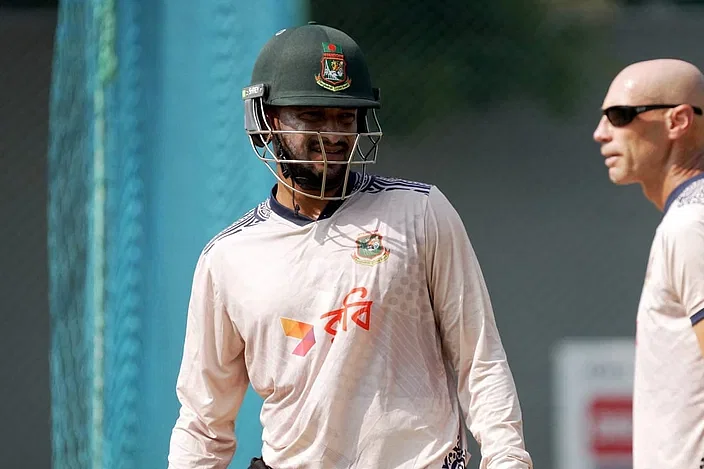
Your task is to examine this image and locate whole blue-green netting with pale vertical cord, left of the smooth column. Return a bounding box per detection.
[48,0,142,469]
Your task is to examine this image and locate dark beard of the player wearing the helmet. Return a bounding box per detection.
[277,139,349,192]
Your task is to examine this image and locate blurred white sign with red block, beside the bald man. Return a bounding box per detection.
[553,338,635,469]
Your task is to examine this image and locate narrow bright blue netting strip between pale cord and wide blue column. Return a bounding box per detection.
[104,0,145,469]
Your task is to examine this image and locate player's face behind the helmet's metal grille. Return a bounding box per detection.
[271,106,357,189]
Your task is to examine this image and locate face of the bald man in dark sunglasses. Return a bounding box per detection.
[594,78,670,185]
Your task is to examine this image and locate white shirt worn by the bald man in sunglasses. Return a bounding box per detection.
[633,176,704,469]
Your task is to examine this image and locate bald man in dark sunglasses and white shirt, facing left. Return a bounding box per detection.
[594,59,704,469]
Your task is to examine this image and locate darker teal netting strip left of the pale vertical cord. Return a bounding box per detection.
[48,1,95,469]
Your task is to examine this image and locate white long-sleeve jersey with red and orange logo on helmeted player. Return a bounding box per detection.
[169,174,532,469]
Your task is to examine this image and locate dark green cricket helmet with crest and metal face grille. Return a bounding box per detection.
[242,22,382,200]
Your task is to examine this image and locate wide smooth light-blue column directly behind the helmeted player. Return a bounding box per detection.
[122,0,305,468]
